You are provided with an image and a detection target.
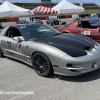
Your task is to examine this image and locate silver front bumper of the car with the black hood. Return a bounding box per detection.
[53,47,100,76]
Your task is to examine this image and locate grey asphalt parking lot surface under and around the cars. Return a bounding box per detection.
[0,19,100,100]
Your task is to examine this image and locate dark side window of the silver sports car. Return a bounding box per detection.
[5,28,22,38]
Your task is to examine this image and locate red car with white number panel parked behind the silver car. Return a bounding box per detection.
[55,19,100,43]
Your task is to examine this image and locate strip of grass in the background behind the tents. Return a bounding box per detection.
[0,9,100,19]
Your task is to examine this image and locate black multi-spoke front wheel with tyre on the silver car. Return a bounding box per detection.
[32,53,53,77]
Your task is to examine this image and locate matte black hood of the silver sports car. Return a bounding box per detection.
[36,33,97,57]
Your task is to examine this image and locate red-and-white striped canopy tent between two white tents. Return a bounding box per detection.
[31,6,58,15]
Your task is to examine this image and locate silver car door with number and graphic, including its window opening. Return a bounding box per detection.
[1,28,28,61]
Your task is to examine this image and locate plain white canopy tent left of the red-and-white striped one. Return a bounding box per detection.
[0,1,31,17]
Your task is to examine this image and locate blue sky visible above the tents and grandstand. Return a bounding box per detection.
[0,0,100,6]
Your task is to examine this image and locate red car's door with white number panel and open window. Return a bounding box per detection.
[75,21,98,40]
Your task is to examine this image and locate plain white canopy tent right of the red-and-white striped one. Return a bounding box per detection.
[52,0,84,14]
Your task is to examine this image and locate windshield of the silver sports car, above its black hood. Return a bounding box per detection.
[20,25,60,40]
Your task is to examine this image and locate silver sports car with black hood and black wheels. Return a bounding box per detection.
[0,24,100,76]
